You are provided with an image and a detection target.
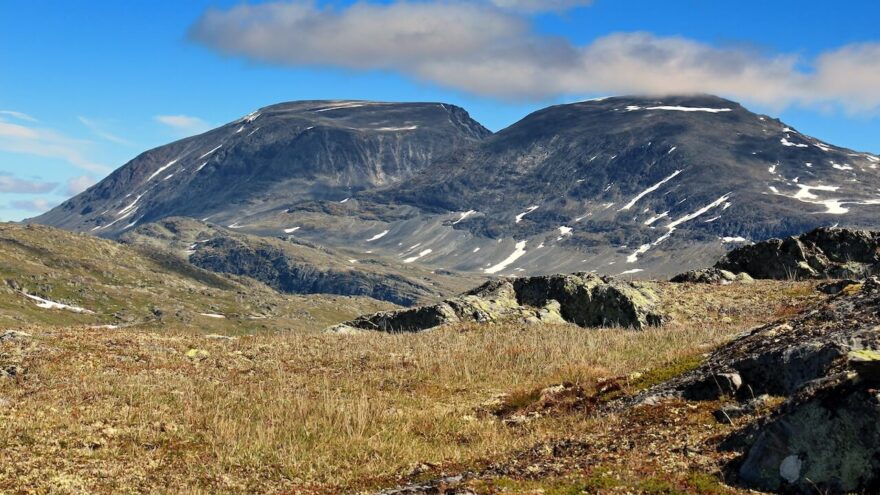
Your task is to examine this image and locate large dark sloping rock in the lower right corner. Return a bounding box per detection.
[633,278,880,493]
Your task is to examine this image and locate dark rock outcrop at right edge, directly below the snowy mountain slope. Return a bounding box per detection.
[715,228,880,280]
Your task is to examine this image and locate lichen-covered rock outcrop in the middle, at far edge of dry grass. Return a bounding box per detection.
[330,273,662,332]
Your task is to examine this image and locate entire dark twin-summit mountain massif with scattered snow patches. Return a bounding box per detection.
[35,95,880,277]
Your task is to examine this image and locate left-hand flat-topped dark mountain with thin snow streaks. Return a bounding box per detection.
[34,101,490,236]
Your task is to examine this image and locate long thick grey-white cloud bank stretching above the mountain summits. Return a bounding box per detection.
[190,0,880,112]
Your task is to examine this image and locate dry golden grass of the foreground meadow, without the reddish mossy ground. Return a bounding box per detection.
[0,282,815,493]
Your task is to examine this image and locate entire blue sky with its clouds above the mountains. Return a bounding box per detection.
[0,0,880,221]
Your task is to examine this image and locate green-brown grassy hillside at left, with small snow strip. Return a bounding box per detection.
[0,224,392,333]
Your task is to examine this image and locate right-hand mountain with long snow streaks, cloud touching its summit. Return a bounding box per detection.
[264,96,880,276]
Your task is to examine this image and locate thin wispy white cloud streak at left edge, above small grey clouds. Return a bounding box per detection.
[0,114,112,173]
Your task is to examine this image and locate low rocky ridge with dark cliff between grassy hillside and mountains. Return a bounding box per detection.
[120,217,478,306]
